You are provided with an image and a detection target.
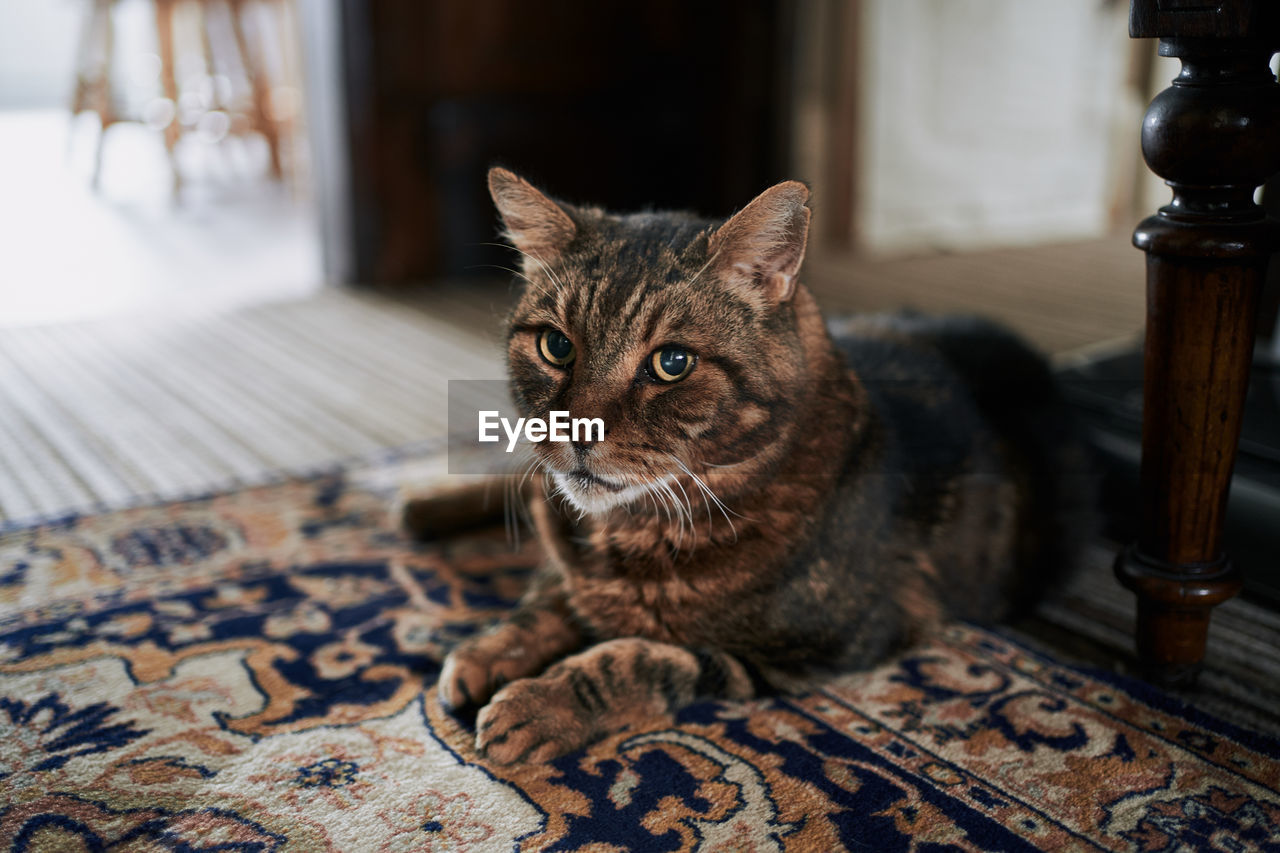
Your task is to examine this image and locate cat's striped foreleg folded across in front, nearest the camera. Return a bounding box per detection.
[476,638,755,765]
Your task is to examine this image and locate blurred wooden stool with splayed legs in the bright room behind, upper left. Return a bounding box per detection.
[70,0,300,191]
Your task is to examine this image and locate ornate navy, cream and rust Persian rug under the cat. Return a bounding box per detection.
[0,462,1280,853]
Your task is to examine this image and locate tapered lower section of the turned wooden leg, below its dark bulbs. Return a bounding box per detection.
[1117,255,1261,684]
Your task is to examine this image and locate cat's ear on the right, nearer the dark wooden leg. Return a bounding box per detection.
[708,181,810,305]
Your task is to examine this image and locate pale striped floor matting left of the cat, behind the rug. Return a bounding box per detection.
[0,289,503,526]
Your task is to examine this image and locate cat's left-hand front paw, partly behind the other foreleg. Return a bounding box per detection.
[436,589,582,711]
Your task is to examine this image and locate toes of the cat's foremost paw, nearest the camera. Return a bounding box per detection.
[476,679,591,765]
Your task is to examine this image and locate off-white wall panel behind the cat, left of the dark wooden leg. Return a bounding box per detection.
[856,0,1138,252]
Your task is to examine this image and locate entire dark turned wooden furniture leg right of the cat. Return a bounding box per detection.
[1116,0,1280,685]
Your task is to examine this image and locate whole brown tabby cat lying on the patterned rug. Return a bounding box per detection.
[404,163,1087,763]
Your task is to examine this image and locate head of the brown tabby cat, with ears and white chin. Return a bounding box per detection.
[489,169,812,514]
